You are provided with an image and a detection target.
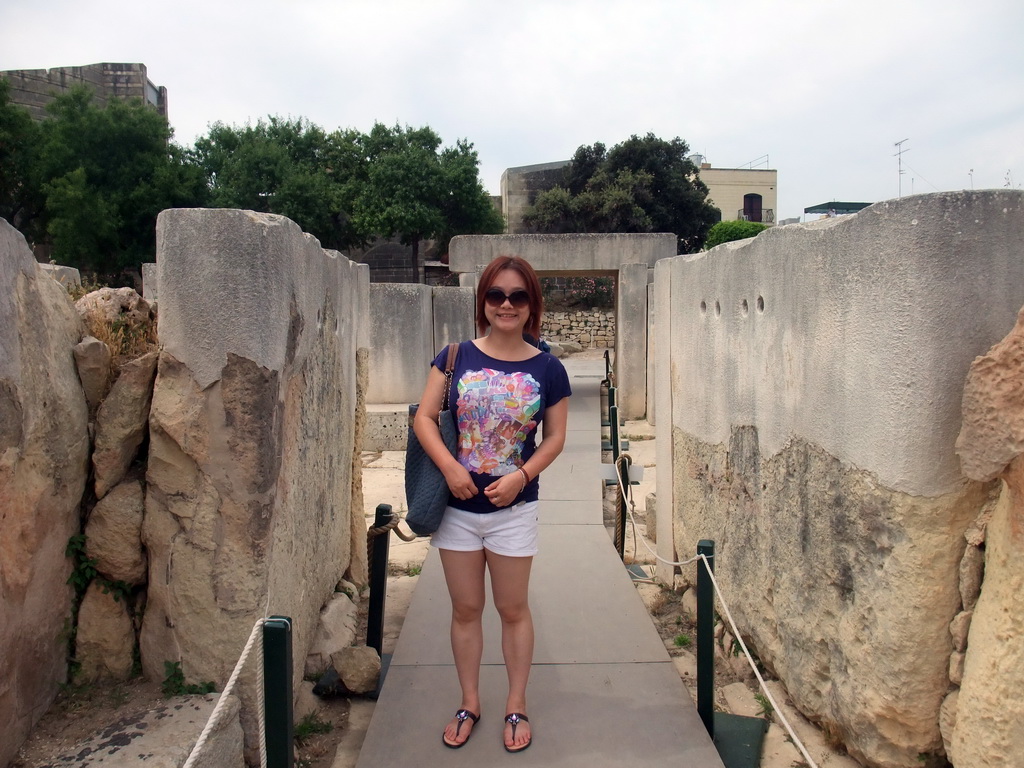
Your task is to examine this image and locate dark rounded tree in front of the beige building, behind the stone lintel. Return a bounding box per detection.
[523,133,720,253]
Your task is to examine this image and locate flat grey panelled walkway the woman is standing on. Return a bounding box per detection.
[356,359,722,768]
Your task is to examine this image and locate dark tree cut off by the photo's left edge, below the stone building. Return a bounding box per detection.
[0,78,43,238]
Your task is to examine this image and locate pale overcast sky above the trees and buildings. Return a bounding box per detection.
[0,0,1024,219]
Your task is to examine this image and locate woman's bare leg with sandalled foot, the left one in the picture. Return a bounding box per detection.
[438,549,486,743]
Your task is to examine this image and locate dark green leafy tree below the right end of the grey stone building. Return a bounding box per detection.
[37,87,205,274]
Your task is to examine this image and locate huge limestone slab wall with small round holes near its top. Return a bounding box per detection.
[654,190,1024,766]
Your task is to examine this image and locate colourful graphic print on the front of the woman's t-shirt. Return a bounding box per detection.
[458,368,541,476]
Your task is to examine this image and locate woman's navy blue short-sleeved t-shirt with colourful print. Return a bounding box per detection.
[431,341,572,513]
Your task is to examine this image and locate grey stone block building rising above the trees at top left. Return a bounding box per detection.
[0,62,167,120]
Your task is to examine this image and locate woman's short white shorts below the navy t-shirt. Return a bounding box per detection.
[430,502,540,557]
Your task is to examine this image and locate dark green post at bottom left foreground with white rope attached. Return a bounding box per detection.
[263,616,295,768]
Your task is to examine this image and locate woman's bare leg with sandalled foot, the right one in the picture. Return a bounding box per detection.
[484,550,534,748]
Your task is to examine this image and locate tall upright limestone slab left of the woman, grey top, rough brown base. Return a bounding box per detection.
[140,210,368,753]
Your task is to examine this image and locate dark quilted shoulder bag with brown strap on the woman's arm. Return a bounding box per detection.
[406,344,459,536]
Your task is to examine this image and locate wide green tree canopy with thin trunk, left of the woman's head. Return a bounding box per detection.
[194,117,504,282]
